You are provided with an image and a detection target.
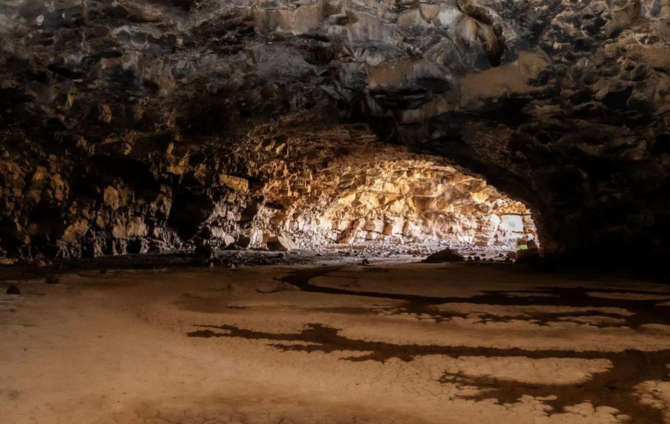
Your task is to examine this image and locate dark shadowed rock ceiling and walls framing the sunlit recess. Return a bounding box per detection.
[0,0,670,264]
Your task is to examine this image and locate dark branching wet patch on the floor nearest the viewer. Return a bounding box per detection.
[188,324,670,423]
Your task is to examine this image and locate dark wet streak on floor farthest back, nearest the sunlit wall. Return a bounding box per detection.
[281,267,670,329]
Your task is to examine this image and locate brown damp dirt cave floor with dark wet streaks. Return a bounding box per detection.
[0,262,670,424]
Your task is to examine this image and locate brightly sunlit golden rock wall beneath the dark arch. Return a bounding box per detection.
[255,142,537,251]
